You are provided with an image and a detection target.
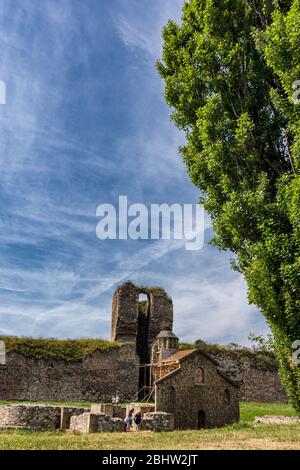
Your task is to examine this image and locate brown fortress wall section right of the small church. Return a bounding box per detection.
[212,350,288,403]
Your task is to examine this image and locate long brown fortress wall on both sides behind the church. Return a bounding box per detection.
[0,344,287,403]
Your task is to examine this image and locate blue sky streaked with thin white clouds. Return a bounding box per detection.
[0,0,268,344]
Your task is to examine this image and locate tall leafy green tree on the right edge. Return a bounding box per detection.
[157,0,300,412]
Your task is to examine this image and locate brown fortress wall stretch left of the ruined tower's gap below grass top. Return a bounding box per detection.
[0,345,139,402]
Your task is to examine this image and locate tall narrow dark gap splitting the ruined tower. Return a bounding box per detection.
[136,292,150,398]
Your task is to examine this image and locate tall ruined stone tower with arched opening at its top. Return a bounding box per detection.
[111,282,173,394]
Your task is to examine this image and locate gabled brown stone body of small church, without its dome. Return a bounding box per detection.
[155,350,239,429]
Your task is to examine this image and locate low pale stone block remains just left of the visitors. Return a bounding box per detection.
[70,413,125,434]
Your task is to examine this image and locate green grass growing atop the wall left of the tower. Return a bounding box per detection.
[0,336,125,362]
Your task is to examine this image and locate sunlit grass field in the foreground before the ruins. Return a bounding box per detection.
[0,403,300,450]
